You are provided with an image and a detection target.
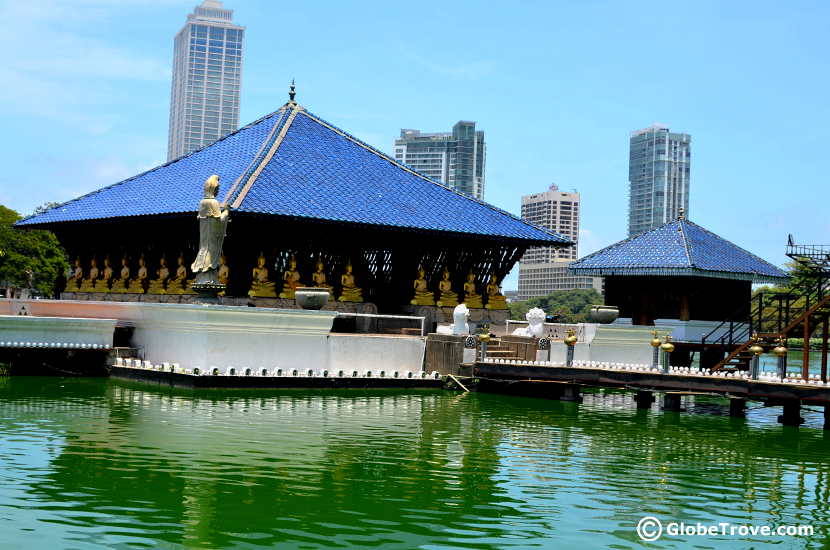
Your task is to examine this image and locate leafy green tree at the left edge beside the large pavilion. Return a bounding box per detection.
[0,205,68,296]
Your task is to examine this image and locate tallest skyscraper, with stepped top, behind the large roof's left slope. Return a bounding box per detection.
[167,0,245,160]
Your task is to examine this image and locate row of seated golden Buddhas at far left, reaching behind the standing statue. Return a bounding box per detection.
[66,254,228,294]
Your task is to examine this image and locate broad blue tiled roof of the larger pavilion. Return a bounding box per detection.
[18,103,570,244]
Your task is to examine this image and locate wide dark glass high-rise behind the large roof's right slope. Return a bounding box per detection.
[394,120,486,199]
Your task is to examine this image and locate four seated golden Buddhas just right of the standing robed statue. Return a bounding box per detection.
[248,254,363,302]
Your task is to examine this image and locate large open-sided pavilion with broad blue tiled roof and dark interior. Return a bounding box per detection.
[17,98,569,311]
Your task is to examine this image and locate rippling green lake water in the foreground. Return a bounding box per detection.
[0,377,830,550]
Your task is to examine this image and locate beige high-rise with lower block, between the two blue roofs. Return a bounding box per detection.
[518,185,602,300]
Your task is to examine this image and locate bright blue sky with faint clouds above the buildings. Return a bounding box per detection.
[0,0,830,289]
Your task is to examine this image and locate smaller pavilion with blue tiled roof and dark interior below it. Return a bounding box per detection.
[570,215,788,325]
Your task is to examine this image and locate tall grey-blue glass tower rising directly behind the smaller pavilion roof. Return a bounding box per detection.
[628,124,692,237]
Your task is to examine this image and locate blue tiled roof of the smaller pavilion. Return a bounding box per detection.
[570,219,788,282]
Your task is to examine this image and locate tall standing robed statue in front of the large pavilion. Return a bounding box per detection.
[190,174,229,289]
